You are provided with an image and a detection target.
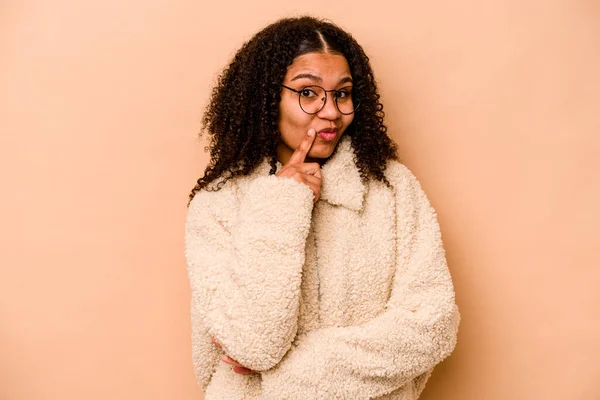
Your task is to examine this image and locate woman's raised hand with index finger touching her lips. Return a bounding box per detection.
[276,128,322,201]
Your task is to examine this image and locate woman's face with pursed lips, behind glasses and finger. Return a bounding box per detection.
[277,53,354,165]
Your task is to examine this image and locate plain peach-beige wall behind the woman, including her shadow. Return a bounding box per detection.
[0,0,600,400]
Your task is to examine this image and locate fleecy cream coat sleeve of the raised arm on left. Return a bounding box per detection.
[185,175,313,376]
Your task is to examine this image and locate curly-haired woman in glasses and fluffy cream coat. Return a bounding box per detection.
[186,17,459,400]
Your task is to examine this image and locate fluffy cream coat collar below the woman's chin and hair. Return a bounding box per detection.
[251,136,367,211]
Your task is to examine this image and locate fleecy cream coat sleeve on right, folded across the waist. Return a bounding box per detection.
[262,163,460,400]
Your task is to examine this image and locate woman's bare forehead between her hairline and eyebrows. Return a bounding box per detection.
[285,53,352,81]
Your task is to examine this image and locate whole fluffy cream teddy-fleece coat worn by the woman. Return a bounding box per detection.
[185,137,460,400]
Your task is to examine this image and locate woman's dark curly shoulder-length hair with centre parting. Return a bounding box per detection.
[188,16,397,205]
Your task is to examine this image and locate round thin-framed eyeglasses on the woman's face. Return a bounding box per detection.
[281,85,358,115]
